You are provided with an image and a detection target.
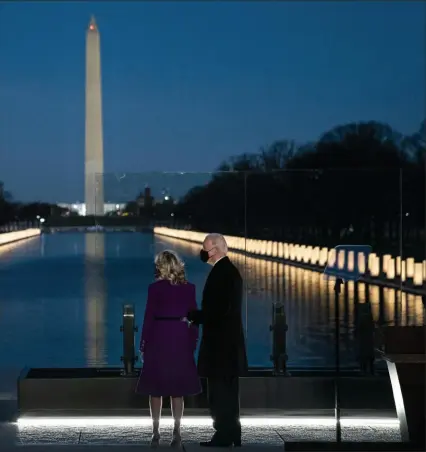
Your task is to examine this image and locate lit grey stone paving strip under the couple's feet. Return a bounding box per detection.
[0,423,400,448]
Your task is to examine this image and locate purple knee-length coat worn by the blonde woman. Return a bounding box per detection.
[136,280,201,397]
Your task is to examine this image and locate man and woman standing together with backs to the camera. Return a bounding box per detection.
[136,234,247,447]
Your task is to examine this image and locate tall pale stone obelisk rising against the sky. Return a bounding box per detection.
[84,16,104,215]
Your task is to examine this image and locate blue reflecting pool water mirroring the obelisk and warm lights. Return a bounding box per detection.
[0,233,424,367]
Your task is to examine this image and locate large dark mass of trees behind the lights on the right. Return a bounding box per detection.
[176,122,426,254]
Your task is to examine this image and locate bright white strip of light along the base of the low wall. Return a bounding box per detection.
[17,416,399,428]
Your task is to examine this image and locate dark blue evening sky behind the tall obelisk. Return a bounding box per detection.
[0,1,426,201]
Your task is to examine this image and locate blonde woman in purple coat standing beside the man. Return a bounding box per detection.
[136,251,201,447]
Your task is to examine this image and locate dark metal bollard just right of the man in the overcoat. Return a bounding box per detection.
[269,303,289,376]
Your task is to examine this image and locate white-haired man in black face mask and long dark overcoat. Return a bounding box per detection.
[188,234,247,447]
